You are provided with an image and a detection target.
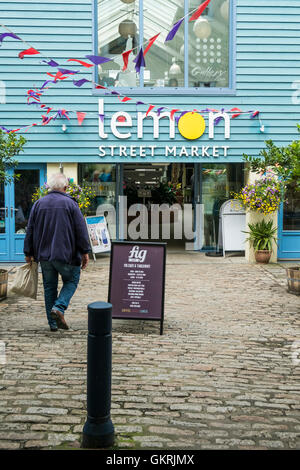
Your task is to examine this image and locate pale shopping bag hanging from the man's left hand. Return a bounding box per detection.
[8,261,38,299]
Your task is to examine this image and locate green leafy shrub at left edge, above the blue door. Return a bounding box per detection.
[0,129,26,183]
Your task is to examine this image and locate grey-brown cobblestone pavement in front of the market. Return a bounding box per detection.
[0,253,300,450]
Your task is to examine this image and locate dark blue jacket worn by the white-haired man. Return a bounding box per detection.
[24,191,90,266]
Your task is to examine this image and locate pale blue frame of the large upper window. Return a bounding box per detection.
[92,0,236,96]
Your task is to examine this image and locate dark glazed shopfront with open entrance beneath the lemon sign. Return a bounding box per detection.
[79,163,245,251]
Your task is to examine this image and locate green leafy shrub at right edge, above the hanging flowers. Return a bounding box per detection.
[244,124,300,191]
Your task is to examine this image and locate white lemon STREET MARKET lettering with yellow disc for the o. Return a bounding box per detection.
[99,99,230,158]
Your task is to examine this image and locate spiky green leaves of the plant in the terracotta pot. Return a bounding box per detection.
[244,220,277,251]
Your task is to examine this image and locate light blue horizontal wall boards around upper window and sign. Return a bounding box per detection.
[0,0,300,162]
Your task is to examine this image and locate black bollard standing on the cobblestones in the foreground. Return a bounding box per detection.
[81,302,114,449]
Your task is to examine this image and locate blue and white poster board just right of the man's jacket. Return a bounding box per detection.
[85,215,111,260]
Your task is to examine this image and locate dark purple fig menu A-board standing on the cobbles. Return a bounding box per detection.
[108,241,166,335]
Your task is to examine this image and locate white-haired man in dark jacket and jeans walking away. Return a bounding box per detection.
[24,173,90,331]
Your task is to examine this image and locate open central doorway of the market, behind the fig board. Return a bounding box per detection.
[123,163,196,250]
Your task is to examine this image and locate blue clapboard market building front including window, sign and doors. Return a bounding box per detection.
[0,0,300,261]
